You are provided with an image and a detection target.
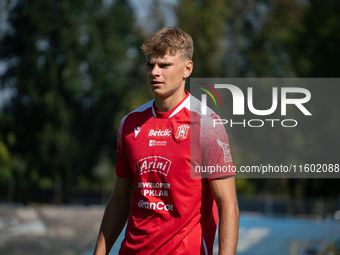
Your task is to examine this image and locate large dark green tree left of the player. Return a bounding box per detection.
[0,0,148,202]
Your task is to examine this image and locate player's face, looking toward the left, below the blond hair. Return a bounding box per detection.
[145,53,192,96]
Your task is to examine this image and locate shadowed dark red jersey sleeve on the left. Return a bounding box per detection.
[116,116,133,178]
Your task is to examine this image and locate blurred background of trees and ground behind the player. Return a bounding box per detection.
[0,0,340,255]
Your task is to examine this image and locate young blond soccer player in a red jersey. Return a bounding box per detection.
[94,28,239,255]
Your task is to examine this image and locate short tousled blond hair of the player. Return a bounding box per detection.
[141,27,194,60]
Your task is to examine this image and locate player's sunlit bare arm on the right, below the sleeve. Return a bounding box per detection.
[210,177,239,255]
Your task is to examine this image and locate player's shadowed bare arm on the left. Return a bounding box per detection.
[94,176,135,255]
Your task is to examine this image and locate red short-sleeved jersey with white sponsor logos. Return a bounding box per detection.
[116,93,234,255]
